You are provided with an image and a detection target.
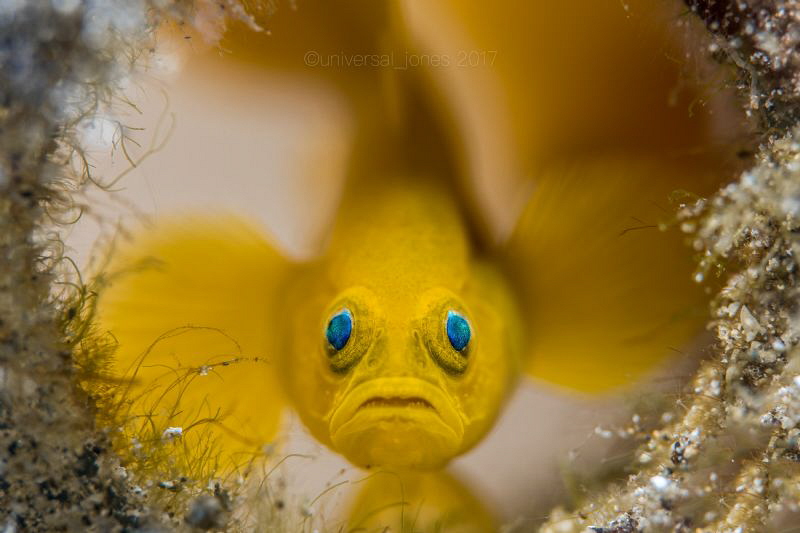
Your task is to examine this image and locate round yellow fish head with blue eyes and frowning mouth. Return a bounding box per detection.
[285,181,518,469]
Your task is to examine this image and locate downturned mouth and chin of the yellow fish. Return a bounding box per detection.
[329,377,464,469]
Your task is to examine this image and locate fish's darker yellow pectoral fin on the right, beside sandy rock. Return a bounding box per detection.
[506,156,711,392]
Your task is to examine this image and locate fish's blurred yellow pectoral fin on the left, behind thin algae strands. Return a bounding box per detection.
[98,219,291,472]
